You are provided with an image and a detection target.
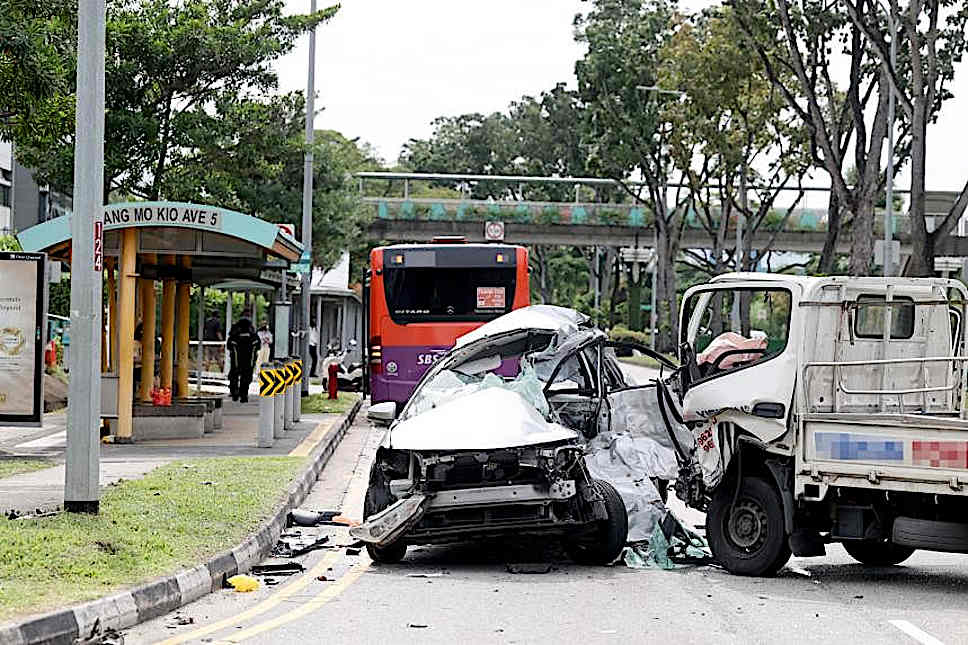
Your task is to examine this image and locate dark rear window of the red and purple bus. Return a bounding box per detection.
[384,266,516,324]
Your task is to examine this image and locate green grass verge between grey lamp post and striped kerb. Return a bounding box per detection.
[0,457,305,621]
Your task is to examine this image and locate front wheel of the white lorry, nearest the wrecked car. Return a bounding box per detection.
[706,477,790,576]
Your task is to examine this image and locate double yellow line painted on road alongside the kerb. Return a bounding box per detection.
[157,552,370,645]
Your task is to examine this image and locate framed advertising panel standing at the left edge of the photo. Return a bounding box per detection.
[0,253,46,426]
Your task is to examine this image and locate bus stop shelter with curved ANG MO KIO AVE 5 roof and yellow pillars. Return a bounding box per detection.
[18,202,303,442]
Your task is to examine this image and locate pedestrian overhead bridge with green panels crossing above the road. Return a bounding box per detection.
[356,172,968,256]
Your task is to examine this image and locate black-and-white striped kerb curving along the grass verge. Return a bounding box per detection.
[0,399,363,645]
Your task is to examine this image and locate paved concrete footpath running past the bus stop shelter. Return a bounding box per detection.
[0,396,362,514]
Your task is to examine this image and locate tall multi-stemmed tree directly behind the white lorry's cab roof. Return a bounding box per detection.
[732,0,888,275]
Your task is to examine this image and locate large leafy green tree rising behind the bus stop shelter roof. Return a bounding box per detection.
[14,0,337,201]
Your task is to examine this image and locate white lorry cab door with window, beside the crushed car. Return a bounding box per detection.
[680,282,799,441]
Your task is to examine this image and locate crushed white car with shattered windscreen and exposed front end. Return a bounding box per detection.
[351,305,676,564]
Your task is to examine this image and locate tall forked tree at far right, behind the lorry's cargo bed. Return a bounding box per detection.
[843,0,968,276]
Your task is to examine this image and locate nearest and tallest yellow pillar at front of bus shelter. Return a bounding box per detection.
[115,228,138,441]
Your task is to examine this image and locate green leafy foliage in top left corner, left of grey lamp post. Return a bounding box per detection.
[0,0,77,140]
